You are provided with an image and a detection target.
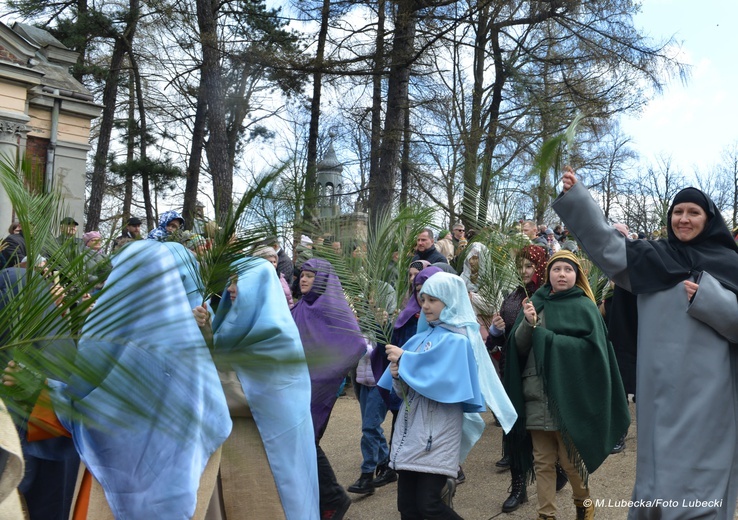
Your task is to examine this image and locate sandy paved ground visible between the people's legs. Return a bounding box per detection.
[320,389,636,520]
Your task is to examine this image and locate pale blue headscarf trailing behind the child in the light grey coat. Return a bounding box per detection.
[418,273,518,462]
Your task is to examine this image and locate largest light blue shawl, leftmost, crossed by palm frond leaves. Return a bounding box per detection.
[52,240,231,520]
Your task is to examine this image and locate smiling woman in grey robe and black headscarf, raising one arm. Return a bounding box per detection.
[553,168,738,520]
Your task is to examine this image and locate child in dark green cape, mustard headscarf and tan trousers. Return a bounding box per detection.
[505,251,630,520]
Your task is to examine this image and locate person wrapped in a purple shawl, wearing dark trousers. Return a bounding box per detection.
[292,258,366,518]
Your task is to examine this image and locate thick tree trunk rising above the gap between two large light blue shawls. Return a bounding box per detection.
[196,0,233,223]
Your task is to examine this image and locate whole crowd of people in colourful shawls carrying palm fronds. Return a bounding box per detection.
[0,169,738,520]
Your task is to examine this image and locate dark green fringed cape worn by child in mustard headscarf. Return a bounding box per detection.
[504,284,630,483]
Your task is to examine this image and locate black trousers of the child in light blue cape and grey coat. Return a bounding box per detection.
[397,471,463,520]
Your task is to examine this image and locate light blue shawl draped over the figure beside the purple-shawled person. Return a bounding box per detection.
[213,258,320,520]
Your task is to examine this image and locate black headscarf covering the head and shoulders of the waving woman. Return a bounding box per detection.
[626,188,738,294]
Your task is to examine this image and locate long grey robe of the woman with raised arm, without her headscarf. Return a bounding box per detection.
[553,182,738,520]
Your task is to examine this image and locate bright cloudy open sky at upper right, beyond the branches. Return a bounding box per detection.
[622,0,738,174]
